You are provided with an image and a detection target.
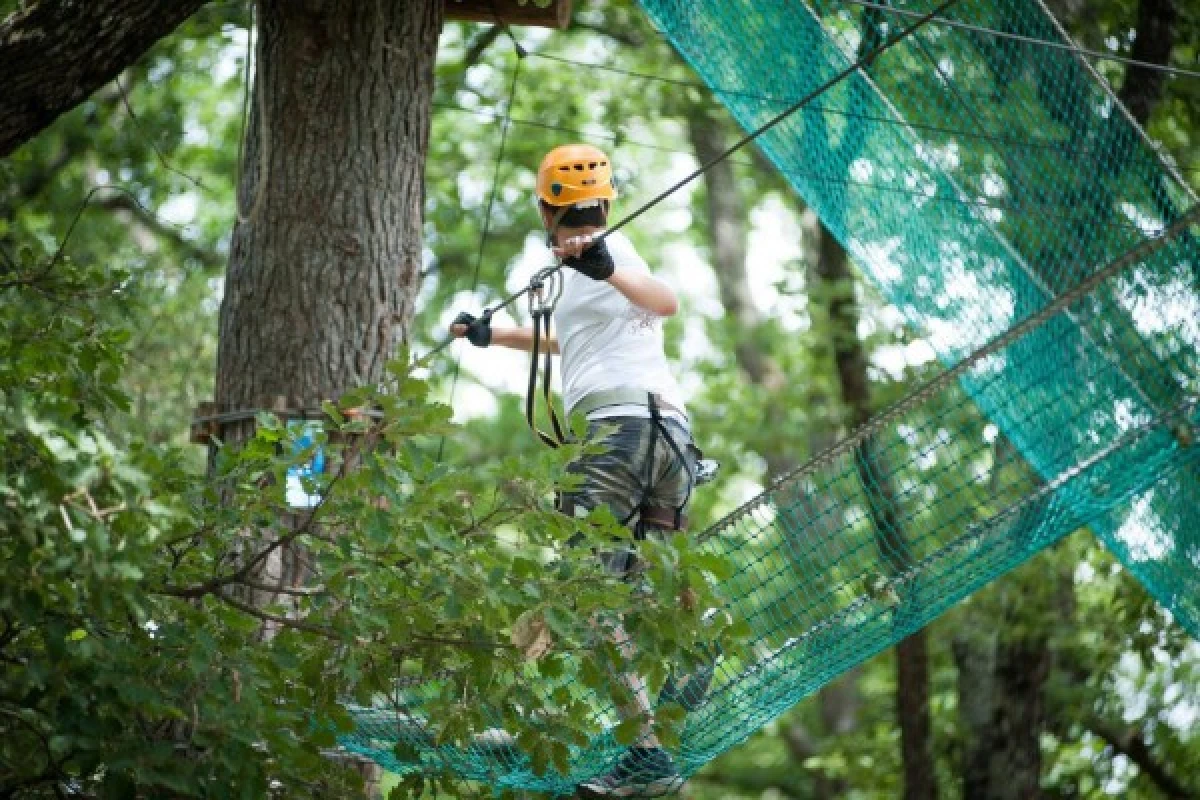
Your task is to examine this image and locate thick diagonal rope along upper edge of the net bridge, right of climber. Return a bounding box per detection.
[701,204,1200,539]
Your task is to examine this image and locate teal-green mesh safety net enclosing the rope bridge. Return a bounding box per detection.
[341,0,1200,794]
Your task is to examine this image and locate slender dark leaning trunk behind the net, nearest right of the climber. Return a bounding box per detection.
[816,227,937,800]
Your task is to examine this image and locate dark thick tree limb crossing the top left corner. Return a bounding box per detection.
[0,0,206,157]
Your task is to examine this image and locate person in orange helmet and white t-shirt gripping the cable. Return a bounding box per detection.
[451,144,707,798]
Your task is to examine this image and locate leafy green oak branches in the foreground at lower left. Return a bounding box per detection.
[0,217,729,796]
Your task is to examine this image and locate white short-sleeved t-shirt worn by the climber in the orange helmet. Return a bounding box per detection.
[554,231,686,425]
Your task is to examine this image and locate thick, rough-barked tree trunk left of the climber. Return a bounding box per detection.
[216,0,442,796]
